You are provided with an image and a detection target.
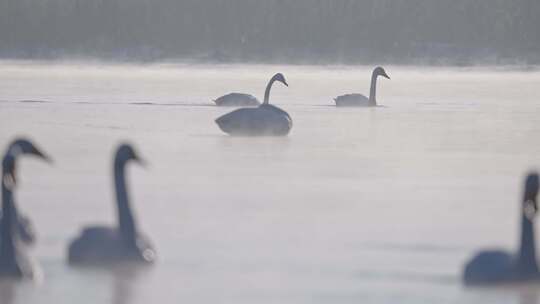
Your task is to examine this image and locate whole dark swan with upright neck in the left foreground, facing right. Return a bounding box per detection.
[68,144,156,266]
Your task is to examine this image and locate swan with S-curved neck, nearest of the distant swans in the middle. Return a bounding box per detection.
[216,73,292,136]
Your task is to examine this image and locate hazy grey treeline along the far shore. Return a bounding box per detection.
[0,0,540,64]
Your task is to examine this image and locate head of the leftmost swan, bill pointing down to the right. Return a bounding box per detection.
[2,138,52,188]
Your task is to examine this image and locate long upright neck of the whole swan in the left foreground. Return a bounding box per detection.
[114,160,136,242]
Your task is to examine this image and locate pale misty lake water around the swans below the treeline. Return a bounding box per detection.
[0,62,540,304]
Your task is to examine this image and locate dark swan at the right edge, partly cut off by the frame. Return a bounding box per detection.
[463,173,540,285]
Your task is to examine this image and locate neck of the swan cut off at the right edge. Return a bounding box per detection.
[517,200,538,274]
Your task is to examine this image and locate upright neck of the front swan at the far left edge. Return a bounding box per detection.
[0,168,16,265]
